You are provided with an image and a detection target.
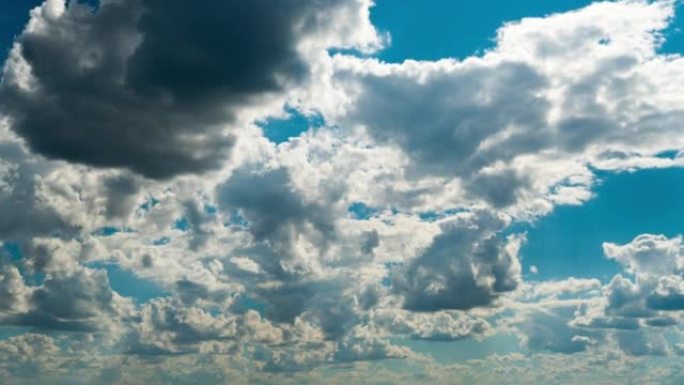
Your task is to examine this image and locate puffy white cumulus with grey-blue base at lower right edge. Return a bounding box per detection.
[516,234,684,356]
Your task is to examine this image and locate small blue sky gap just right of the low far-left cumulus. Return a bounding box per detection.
[88,262,169,304]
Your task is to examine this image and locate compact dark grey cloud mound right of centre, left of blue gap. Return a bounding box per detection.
[393,211,520,311]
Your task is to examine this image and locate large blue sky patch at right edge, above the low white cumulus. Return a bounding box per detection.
[517,168,684,281]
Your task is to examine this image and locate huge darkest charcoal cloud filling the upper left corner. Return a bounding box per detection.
[0,0,359,178]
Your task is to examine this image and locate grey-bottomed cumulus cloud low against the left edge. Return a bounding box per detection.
[1,241,132,335]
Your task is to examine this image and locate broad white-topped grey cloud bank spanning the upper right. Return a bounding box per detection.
[321,1,682,213]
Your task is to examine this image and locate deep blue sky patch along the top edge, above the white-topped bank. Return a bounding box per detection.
[371,0,592,62]
